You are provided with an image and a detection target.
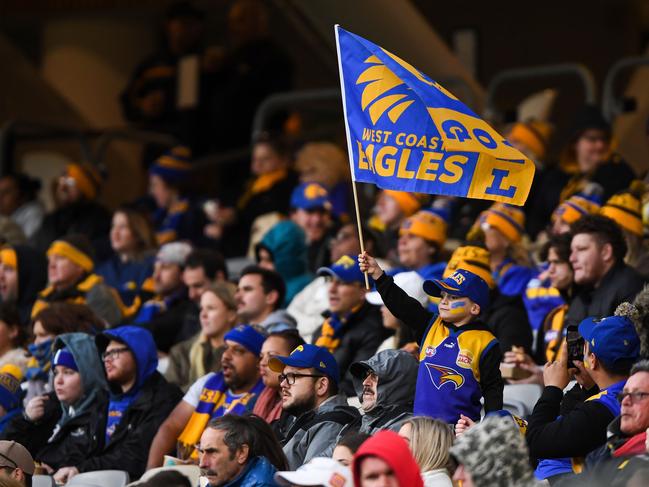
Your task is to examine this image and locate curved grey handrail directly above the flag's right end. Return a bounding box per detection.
[484,63,597,120]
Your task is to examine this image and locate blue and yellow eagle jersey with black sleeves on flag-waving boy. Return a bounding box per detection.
[376,274,504,423]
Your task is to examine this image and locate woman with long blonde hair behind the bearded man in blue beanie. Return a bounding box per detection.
[165,282,237,391]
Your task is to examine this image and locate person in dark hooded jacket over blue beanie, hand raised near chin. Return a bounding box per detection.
[2,333,106,472]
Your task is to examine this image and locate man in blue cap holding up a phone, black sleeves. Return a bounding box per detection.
[526,316,640,484]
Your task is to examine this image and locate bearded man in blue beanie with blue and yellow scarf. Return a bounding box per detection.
[148,325,265,468]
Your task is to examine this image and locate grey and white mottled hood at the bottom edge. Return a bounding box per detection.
[450,416,544,487]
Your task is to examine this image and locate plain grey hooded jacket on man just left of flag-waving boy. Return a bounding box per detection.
[350,350,419,435]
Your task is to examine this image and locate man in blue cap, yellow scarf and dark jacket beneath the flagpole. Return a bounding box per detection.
[312,255,391,396]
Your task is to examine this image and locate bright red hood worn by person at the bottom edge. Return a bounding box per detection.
[352,430,424,487]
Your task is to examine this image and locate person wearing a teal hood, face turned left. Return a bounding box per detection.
[255,220,314,308]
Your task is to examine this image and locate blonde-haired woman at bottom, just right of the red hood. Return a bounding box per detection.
[399,416,453,487]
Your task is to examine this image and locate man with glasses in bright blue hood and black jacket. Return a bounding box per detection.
[54,326,182,482]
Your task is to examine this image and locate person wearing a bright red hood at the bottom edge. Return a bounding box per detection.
[352,430,424,487]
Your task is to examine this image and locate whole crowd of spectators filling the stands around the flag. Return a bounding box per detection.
[0,0,649,487]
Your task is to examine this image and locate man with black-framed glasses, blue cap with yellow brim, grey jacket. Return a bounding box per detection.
[268,345,358,470]
